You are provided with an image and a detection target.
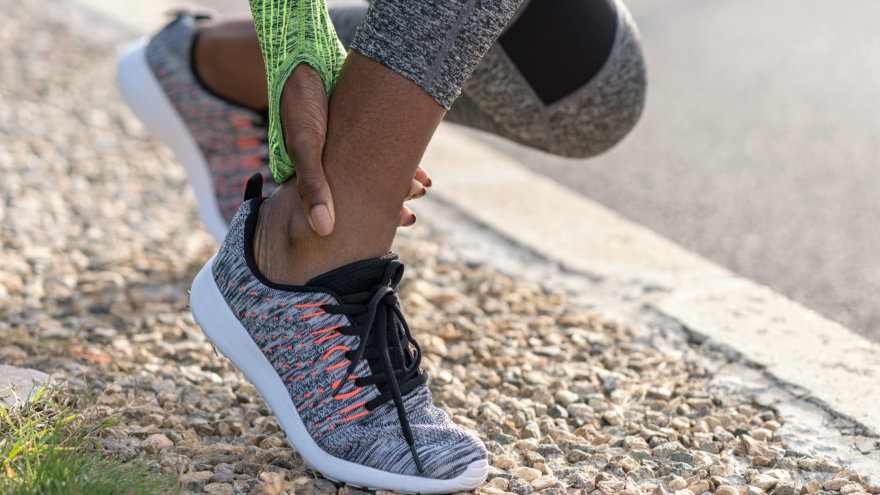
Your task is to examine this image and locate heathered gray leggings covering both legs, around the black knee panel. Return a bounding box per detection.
[330,0,646,158]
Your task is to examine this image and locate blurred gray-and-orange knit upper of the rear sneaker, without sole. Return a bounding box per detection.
[146,13,274,221]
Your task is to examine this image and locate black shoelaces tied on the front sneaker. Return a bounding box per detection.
[323,260,427,474]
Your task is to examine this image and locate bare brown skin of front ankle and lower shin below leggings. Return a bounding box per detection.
[254,52,445,285]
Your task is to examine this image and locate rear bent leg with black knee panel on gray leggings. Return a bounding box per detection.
[197,0,646,158]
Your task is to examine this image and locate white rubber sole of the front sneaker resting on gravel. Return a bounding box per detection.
[190,258,489,493]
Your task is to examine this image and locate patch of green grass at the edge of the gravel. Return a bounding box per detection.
[0,385,172,495]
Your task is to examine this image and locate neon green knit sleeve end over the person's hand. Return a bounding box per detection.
[250,0,345,184]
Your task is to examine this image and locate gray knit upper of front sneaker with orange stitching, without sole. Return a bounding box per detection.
[211,199,487,482]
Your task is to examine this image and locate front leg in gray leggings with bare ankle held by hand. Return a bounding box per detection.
[255,2,513,284]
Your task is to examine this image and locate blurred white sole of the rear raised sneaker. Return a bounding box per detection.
[116,38,227,242]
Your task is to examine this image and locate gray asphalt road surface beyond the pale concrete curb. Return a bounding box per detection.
[484,0,880,341]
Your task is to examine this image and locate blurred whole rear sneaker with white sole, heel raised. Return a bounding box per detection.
[117,13,274,242]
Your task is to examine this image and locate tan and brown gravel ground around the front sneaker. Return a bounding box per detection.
[0,0,880,495]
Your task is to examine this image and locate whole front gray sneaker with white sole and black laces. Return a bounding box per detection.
[190,176,488,493]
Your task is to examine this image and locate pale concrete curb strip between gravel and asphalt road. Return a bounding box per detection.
[423,126,880,435]
